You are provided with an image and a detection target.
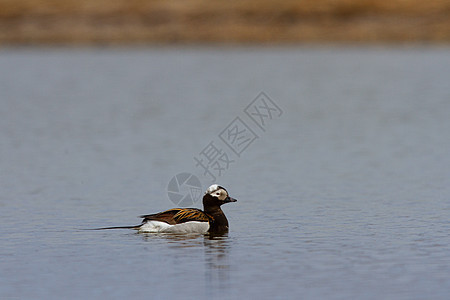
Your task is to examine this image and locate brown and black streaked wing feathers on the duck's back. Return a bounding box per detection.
[141,208,212,225]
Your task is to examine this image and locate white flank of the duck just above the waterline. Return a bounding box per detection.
[139,221,209,233]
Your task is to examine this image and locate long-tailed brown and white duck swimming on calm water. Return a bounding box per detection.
[97,184,237,234]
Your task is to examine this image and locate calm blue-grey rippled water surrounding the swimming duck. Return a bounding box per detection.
[0,47,450,299]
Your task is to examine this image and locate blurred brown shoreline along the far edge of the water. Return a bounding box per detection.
[0,0,450,45]
